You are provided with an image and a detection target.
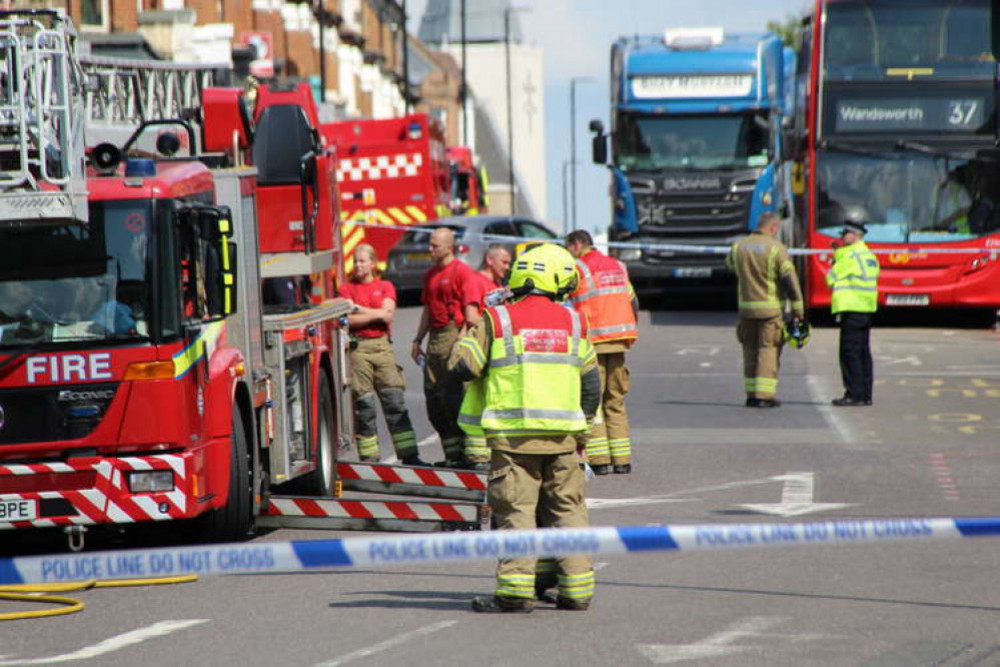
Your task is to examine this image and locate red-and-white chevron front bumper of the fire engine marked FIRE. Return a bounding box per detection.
[0,454,190,530]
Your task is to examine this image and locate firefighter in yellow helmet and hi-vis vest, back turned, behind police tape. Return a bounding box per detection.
[449,244,600,612]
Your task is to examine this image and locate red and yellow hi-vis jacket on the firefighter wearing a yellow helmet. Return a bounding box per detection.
[448,296,601,454]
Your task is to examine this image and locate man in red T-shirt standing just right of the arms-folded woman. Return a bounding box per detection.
[410,227,474,468]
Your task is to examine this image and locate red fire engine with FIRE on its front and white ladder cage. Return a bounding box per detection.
[0,11,481,547]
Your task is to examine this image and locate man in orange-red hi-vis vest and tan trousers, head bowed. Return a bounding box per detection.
[566,229,639,475]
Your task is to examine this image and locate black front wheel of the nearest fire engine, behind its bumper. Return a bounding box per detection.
[201,413,253,542]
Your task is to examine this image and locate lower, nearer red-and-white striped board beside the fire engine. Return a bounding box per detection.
[265,498,479,523]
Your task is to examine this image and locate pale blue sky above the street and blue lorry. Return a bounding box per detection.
[407,0,812,232]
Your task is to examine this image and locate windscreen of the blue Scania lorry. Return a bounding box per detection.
[617,114,770,171]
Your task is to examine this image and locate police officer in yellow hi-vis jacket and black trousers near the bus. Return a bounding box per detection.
[826,206,879,407]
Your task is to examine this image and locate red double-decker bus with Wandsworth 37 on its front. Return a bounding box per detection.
[794,0,1000,320]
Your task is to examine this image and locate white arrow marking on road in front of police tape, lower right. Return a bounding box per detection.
[636,616,826,665]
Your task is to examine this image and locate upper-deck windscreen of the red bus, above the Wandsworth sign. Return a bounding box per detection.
[824,0,994,80]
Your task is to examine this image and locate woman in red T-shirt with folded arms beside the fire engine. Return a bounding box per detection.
[340,243,427,465]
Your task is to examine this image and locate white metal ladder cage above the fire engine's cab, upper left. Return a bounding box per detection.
[0,10,87,222]
